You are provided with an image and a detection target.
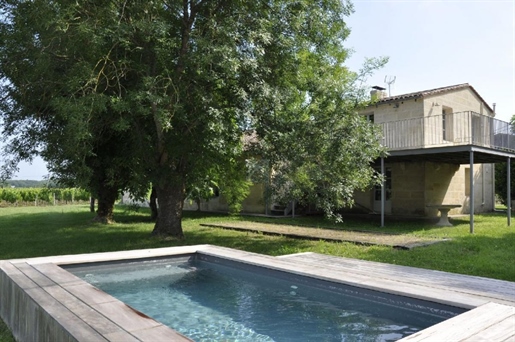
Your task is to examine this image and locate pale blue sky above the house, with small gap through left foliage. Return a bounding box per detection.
[7,0,515,180]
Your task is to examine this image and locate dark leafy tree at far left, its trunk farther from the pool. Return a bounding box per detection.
[0,1,150,222]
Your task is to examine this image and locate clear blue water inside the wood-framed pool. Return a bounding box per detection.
[66,256,464,342]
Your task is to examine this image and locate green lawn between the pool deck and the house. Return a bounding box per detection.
[0,206,515,342]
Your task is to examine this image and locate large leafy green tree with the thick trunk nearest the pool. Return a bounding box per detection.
[0,0,388,238]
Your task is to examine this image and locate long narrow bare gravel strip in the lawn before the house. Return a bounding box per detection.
[201,222,446,249]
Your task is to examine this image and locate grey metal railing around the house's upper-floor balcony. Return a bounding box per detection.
[379,111,515,152]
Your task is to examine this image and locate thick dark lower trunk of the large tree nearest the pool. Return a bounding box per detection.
[152,181,185,239]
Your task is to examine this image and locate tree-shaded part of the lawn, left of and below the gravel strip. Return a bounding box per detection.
[0,207,306,259]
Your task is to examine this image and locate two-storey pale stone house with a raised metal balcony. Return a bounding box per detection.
[185,84,515,222]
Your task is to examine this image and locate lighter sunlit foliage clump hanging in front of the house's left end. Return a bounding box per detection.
[258,52,386,219]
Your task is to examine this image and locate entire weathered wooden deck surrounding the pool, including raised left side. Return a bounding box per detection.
[0,245,515,342]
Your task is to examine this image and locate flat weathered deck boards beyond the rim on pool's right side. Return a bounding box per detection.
[281,253,515,341]
